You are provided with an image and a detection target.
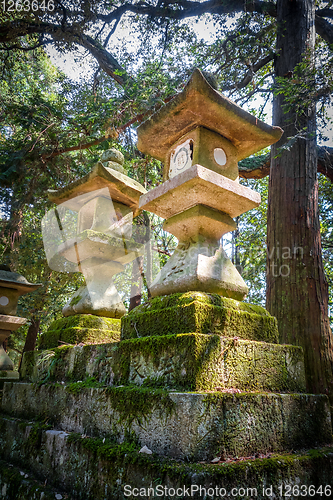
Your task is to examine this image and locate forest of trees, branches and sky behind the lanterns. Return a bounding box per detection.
[0,0,333,402]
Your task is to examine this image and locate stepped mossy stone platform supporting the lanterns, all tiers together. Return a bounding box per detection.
[0,293,333,500]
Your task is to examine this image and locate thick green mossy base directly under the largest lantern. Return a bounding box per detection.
[121,292,278,343]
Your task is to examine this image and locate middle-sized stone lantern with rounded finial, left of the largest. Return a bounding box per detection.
[43,149,146,318]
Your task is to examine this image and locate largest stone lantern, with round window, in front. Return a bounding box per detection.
[138,69,282,300]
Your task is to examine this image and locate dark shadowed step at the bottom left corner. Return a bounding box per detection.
[0,460,73,500]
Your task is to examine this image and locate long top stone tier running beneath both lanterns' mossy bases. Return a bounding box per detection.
[21,333,305,392]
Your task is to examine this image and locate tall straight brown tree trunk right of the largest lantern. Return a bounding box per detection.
[267,0,333,402]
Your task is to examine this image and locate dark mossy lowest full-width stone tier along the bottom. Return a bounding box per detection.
[0,418,333,500]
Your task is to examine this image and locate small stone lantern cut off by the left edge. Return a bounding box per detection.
[0,265,41,382]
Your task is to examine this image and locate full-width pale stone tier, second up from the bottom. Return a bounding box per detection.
[2,381,331,460]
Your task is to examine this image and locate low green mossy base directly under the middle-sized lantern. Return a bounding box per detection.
[38,314,120,349]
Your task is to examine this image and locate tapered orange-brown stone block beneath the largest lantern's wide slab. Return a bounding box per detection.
[163,205,237,241]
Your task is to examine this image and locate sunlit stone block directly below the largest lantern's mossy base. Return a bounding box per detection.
[121,334,305,392]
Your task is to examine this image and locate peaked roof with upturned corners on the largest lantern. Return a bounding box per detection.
[138,69,283,161]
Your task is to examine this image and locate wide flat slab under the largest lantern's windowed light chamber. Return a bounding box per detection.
[139,164,260,219]
